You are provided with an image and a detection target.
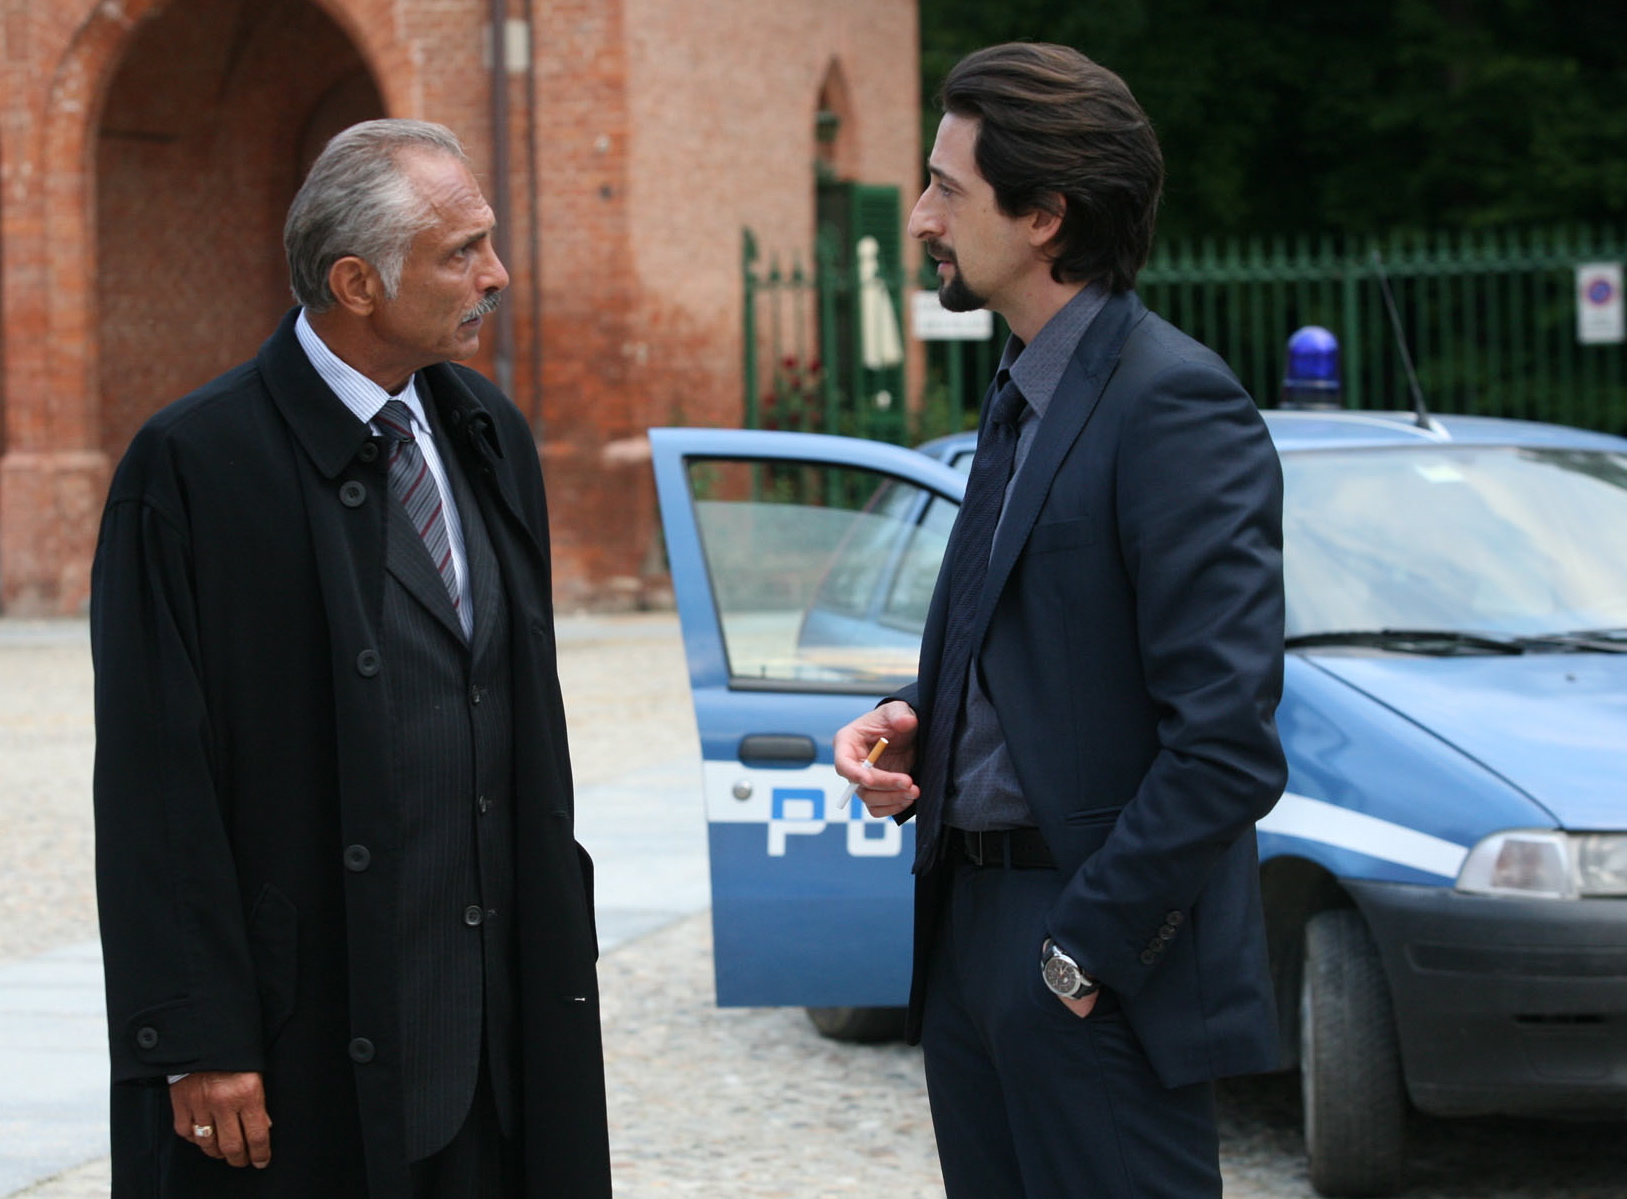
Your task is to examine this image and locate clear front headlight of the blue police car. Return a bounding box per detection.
[1458,828,1627,900]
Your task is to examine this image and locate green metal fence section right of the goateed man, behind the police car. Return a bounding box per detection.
[1137,226,1627,433]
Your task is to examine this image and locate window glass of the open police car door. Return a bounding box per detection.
[688,459,955,693]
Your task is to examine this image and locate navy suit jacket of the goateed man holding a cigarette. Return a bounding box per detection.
[900,293,1287,1087]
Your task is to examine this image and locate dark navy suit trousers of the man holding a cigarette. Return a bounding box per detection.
[921,861,1220,1199]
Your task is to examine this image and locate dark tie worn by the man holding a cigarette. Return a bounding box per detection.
[914,377,1028,874]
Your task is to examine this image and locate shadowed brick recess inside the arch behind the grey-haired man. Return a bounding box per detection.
[94,0,386,459]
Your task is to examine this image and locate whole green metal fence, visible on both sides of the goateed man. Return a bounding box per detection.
[744,226,1627,443]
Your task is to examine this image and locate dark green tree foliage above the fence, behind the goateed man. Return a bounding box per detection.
[921,0,1627,238]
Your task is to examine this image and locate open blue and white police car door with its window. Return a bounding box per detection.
[649,429,965,1038]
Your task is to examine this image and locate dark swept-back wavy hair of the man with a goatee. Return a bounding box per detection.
[939,42,1163,291]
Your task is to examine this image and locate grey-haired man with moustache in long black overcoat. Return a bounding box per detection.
[91,120,610,1199]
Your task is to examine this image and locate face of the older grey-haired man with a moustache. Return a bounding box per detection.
[368,151,509,382]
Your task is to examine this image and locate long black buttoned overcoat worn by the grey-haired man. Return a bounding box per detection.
[91,314,610,1199]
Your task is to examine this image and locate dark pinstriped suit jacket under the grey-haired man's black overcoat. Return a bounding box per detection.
[379,416,519,1162]
